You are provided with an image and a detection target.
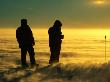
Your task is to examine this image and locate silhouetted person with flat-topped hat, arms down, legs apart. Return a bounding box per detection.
[16,19,36,67]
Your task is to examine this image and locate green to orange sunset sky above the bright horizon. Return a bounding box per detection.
[0,0,110,28]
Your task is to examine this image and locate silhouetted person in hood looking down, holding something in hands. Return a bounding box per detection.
[48,20,64,64]
